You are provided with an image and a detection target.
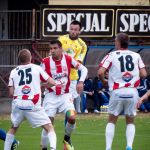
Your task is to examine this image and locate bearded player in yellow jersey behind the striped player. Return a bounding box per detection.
[59,20,87,150]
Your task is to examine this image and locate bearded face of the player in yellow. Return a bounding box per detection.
[69,24,80,39]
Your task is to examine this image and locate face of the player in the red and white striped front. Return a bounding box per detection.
[50,44,62,58]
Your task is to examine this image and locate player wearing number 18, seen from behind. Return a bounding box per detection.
[98,33,147,150]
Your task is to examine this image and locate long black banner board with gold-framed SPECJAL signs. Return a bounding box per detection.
[41,5,150,38]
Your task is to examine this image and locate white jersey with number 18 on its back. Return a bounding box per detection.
[99,50,145,91]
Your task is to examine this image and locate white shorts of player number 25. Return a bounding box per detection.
[11,100,51,128]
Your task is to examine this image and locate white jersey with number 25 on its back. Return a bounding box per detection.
[8,64,49,105]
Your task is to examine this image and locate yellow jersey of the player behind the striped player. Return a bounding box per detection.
[59,34,87,80]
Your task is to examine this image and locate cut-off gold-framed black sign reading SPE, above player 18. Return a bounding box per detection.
[116,9,150,37]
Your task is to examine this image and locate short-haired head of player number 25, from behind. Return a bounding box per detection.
[18,49,32,64]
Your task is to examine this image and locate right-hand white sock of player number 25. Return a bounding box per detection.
[47,131,57,150]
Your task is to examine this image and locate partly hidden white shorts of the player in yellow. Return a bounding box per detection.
[69,80,79,99]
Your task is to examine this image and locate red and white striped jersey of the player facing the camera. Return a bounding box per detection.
[41,54,81,95]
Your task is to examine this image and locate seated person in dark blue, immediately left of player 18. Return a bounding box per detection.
[93,77,109,113]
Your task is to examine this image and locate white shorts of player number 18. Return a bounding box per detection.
[108,88,139,116]
